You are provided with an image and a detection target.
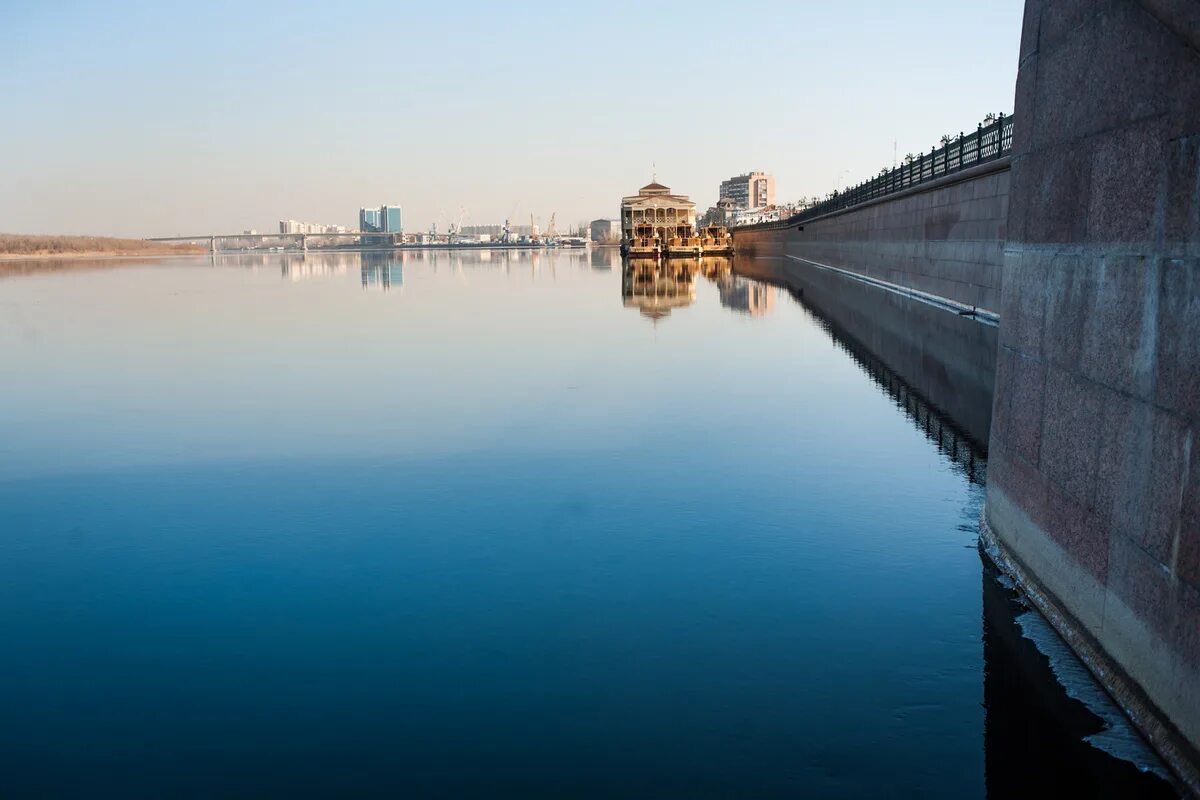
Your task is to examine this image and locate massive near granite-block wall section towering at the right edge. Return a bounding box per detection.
[985,0,1200,790]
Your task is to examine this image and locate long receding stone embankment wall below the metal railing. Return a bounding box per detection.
[733,157,1009,311]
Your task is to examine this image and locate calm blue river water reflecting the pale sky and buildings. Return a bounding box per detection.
[0,249,1169,798]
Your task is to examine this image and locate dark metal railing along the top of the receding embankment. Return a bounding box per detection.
[745,114,1013,229]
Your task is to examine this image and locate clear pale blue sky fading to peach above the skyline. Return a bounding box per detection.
[0,0,1024,236]
